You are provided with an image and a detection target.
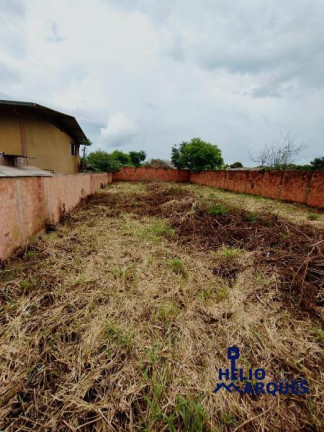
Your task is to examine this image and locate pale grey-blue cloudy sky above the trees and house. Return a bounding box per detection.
[0,0,324,165]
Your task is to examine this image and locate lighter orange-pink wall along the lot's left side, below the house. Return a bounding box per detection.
[0,173,112,260]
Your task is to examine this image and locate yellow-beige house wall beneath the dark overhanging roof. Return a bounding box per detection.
[0,113,80,174]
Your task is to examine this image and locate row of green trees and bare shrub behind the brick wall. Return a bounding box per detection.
[81,137,324,172]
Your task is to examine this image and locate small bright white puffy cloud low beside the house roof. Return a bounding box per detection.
[100,113,137,147]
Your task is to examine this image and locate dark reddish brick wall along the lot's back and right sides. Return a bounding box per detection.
[113,167,324,208]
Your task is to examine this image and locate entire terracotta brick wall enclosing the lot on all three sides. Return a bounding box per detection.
[0,167,324,260]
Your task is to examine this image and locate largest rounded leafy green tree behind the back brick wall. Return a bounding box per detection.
[171,138,224,172]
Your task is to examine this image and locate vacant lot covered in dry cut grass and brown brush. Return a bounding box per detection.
[0,183,324,432]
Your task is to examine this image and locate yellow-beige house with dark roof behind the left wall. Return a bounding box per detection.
[0,100,87,174]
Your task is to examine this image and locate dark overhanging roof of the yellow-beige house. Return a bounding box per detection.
[0,100,88,144]
